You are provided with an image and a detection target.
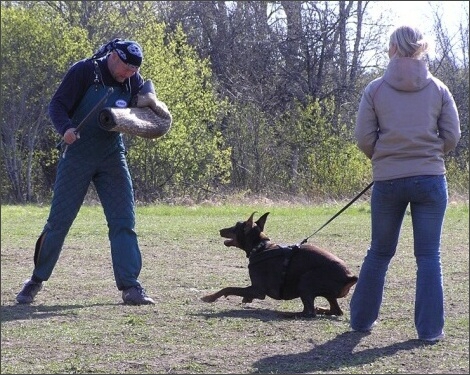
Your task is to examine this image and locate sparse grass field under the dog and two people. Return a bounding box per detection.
[1,201,469,374]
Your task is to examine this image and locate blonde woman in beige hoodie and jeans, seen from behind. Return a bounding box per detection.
[350,26,460,341]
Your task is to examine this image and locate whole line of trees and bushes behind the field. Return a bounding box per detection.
[0,1,469,203]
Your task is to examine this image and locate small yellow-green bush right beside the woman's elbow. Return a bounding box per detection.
[279,99,371,197]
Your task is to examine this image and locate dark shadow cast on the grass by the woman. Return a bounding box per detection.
[253,331,429,374]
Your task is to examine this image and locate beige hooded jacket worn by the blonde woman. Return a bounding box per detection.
[354,57,461,181]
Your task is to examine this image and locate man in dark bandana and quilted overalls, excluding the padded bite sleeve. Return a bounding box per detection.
[16,39,154,305]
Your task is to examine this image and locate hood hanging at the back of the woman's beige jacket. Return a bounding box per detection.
[383,57,432,91]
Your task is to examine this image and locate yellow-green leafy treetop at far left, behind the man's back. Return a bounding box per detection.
[1,7,90,111]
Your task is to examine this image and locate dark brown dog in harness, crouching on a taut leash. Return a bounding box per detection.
[201,212,357,317]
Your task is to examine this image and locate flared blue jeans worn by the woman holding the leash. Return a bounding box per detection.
[350,175,448,339]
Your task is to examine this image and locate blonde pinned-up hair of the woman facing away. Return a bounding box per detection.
[390,25,430,59]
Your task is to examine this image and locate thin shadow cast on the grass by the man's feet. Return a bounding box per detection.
[0,303,118,323]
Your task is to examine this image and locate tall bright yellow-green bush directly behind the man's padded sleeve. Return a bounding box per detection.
[129,22,230,200]
